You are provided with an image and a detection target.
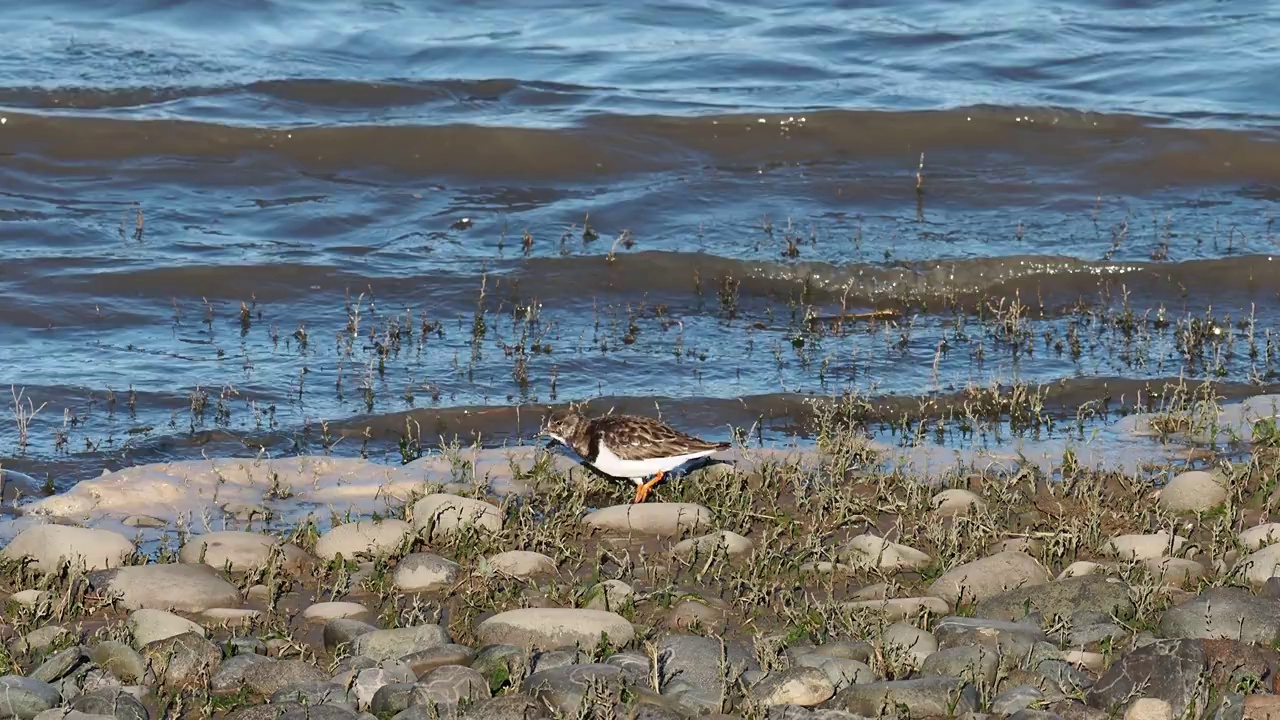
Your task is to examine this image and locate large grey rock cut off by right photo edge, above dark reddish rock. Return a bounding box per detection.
[1160,588,1280,646]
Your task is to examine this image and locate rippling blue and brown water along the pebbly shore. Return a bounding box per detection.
[0,0,1280,487]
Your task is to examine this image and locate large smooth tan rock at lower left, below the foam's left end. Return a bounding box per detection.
[90,565,241,612]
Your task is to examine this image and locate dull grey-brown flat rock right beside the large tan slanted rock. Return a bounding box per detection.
[974,575,1134,620]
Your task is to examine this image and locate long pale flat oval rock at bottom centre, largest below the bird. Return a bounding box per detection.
[475,607,635,650]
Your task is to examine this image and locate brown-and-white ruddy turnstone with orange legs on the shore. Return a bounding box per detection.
[541,407,730,503]
